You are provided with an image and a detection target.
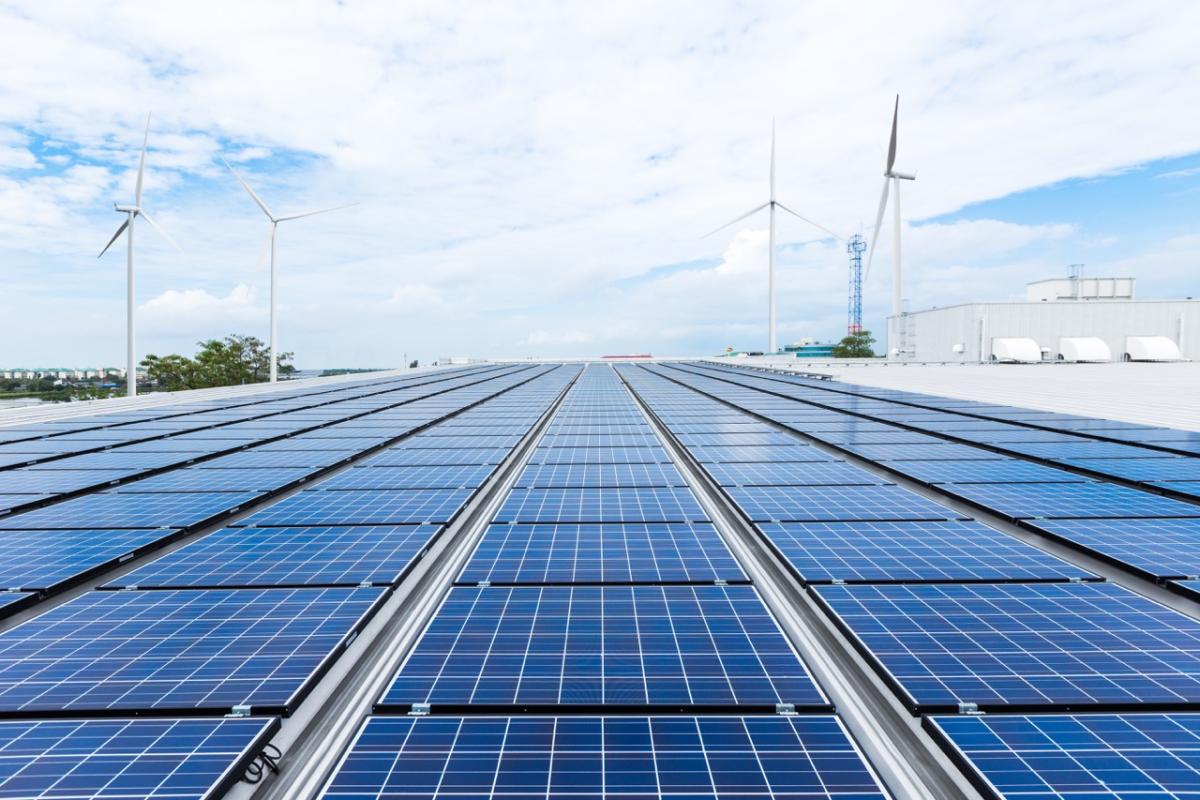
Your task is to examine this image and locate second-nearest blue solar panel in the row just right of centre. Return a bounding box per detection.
[816,583,1200,712]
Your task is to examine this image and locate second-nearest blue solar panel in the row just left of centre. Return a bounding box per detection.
[0,589,384,715]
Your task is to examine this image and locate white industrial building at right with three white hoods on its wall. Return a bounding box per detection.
[887,277,1200,362]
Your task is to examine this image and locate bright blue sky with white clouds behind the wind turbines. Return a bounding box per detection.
[0,0,1200,368]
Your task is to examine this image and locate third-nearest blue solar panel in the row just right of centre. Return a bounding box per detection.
[758,521,1093,583]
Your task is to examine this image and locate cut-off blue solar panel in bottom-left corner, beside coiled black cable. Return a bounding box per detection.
[0,720,278,800]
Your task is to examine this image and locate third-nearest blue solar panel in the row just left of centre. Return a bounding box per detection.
[107,525,439,589]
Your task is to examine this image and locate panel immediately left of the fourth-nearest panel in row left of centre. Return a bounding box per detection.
[0,492,259,530]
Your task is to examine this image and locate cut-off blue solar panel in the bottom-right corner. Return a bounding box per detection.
[928,714,1200,800]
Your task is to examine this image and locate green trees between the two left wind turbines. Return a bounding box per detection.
[142,333,295,391]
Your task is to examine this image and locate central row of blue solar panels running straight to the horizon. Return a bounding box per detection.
[314,365,884,800]
